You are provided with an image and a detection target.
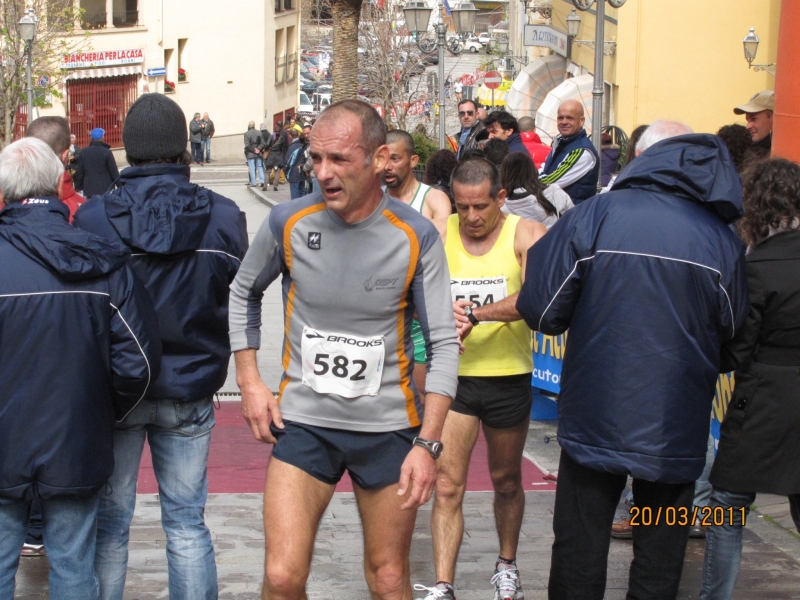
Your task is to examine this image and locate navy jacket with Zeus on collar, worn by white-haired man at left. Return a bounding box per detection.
[0,198,161,503]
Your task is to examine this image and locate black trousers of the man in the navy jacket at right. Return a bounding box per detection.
[548,451,694,600]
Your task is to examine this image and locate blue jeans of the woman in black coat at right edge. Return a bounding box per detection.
[700,487,800,600]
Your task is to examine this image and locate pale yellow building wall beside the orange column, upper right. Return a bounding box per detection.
[553,0,780,133]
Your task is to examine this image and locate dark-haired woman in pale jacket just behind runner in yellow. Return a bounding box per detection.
[500,152,574,229]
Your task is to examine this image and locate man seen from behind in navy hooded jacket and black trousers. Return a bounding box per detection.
[517,121,748,600]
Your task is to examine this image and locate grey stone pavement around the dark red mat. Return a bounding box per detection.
[16,176,800,600]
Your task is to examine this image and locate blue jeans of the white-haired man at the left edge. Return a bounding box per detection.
[0,491,104,600]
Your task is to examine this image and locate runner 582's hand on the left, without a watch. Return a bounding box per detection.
[233,349,283,444]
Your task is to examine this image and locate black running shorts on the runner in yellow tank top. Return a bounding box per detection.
[450,373,533,429]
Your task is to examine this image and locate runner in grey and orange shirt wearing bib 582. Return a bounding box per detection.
[230,100,459,600]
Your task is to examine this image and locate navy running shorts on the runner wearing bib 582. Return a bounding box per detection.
[270,421,420,490]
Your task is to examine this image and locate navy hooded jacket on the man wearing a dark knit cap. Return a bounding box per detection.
[74,164,248,401]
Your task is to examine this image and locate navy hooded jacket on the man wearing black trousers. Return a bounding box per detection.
[517,134,749,483]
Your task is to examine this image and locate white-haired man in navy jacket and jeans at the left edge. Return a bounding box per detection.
[0,138,161,600]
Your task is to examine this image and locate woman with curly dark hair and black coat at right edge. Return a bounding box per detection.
[700,158,800,600]
